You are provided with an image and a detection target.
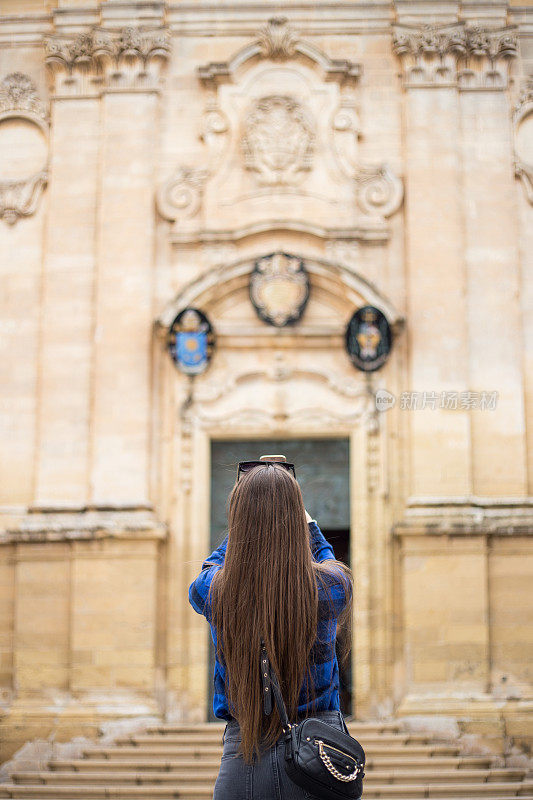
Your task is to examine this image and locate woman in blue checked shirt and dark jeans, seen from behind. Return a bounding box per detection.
[189,462,353,800]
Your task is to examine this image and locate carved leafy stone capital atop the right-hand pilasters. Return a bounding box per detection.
[392,23,518,90]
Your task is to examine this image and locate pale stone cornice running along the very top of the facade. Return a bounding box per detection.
[0,0,533,47]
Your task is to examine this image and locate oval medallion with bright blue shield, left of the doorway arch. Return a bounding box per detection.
[168,308,215,375]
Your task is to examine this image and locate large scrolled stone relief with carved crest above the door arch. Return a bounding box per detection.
[158,18,403,244]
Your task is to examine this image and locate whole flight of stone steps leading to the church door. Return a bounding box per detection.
[0,720,533,800]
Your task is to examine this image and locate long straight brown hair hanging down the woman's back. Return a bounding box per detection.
[209,462,353,764]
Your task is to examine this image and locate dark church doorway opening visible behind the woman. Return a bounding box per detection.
[207,438,352,721]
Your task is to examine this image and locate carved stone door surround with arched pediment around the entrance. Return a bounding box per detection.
[155,258,404,720]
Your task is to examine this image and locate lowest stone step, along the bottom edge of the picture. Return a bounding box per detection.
[0,779,533,800]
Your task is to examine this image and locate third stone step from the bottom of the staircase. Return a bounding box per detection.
[46,754,494,772]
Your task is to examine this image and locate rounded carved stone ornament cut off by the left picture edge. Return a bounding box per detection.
[0,72,48,225]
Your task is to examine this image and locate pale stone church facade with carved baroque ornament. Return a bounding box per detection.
[0,0,533,759]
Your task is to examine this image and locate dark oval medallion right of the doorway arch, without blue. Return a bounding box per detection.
[346,306,392,372]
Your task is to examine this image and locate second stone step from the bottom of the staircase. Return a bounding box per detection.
[11,764,526,788]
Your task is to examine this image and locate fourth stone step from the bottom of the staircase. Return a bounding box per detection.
[83,740,460,759]
